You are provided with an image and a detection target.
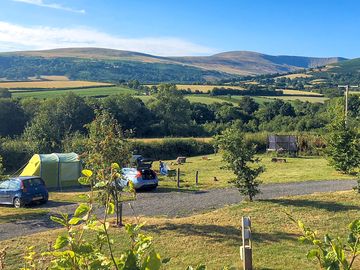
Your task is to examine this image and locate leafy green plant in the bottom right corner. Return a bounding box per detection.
[289,216,360,270]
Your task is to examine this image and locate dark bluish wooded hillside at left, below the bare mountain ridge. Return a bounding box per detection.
[0,56,236,83]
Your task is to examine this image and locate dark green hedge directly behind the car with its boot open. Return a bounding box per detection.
[131,139,214,160]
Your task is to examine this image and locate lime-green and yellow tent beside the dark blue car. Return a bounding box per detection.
[20,153,81,189]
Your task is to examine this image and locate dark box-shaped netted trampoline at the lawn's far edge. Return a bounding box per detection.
[267,135,298,153]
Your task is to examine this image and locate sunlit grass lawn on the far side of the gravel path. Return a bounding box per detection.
[153,154,354,189]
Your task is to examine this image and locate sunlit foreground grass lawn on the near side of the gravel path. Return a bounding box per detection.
[0,191,360,270]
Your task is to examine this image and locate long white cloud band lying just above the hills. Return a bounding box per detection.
[0,21,215,56]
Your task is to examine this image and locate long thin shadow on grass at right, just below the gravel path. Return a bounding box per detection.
[262,199,360,212]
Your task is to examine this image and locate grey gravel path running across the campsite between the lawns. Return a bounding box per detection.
[0,180,355,241]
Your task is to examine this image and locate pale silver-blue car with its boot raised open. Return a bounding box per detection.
[119,157,159,190]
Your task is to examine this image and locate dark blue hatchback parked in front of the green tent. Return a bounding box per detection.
[0,176,49,208]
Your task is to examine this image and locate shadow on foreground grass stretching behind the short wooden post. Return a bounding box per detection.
[144,223,297,246]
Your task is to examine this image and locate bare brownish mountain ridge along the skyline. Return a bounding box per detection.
[0,48,346,75]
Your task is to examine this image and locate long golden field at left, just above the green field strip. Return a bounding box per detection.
[0,81,112,89]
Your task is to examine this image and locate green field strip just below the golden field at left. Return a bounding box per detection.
[12,86,136,98]
